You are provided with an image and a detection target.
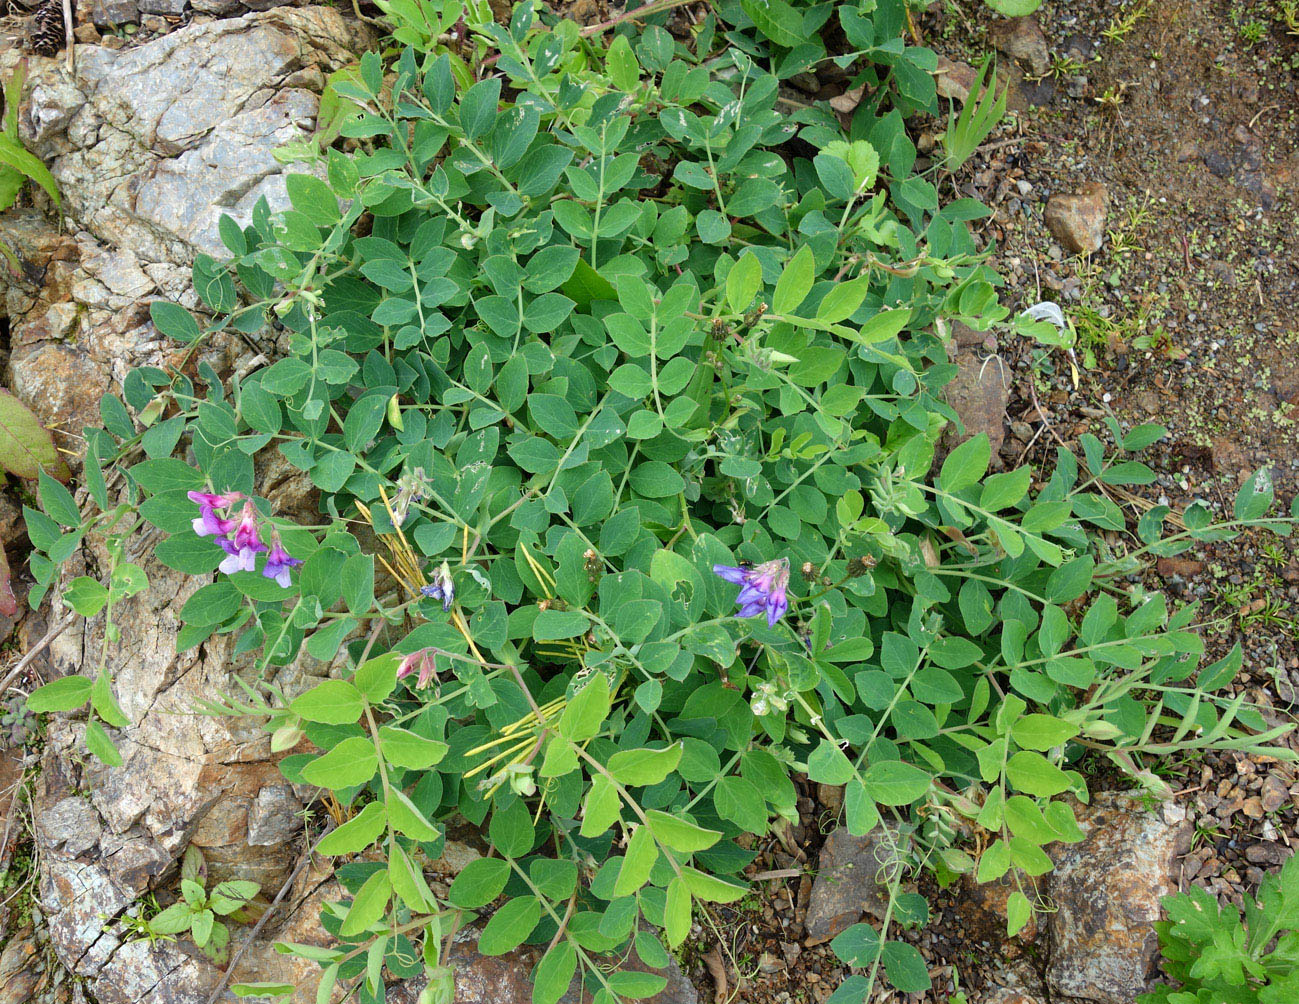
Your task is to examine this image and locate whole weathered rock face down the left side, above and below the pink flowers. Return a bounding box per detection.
[0,17,369,1003]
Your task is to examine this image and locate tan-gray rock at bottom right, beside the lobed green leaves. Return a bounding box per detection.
[1046,792,1191,1004]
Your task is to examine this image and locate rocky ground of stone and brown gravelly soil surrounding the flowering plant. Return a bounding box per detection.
[0,0,1299,1004]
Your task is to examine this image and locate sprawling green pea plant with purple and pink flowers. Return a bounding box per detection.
[27,0,1286,1004]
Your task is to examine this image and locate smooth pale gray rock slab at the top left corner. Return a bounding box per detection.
[10,6,369,262]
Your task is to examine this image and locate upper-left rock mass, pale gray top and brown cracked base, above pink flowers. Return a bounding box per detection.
[0,9,370,470]
